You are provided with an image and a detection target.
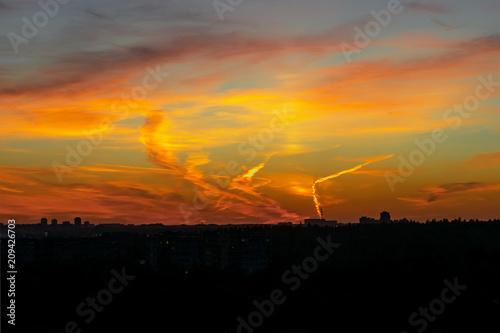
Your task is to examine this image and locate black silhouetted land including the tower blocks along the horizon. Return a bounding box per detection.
[2,211,500,332]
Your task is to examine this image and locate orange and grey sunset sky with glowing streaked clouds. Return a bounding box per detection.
[0,0,500,224]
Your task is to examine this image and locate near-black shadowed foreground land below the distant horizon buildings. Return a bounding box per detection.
[1,222,500,333]
